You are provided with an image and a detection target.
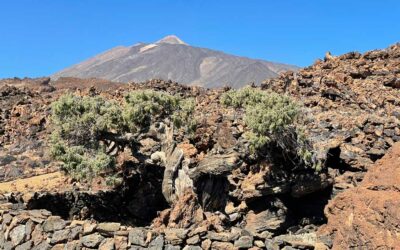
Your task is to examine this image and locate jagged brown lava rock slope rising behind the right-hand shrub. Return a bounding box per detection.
[262,44,400,190]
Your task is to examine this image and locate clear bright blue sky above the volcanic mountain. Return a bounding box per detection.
[0,0,400,78]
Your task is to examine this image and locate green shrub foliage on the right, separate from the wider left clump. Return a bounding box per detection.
[221,87,321,170]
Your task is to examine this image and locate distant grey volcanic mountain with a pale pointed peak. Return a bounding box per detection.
[52,35,298,88]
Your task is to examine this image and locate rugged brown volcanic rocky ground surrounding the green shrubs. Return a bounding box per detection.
[0,45,400,249]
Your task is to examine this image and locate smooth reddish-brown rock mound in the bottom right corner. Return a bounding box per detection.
[318,143,400,249]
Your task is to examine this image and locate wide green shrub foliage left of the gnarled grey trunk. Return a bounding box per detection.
[50,90,194,183]
